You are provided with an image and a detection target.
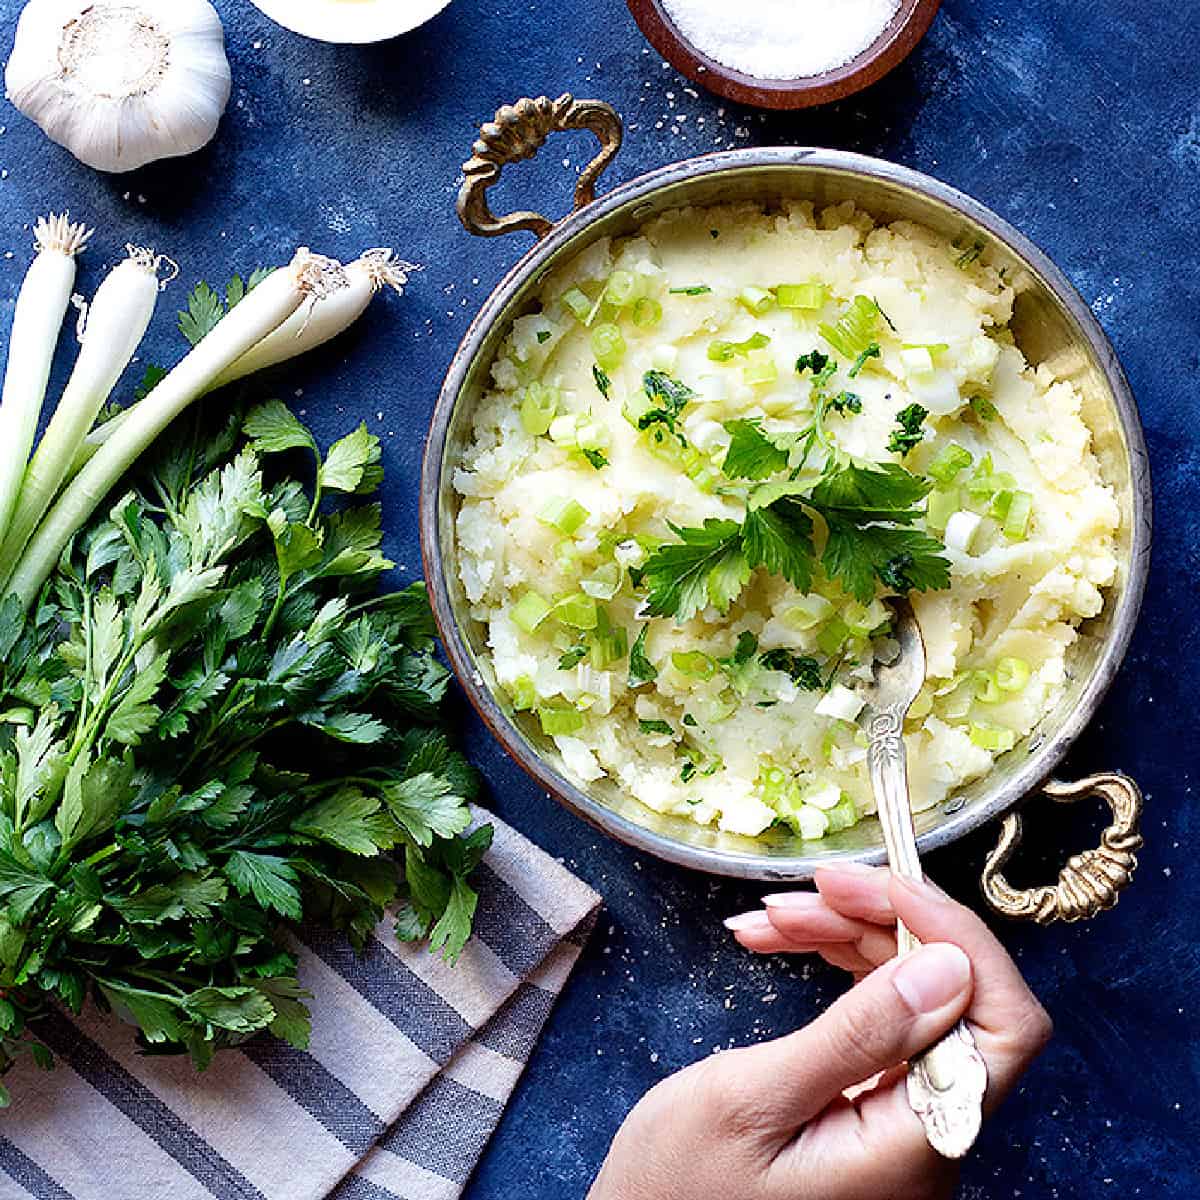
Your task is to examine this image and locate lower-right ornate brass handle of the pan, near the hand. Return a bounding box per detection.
[983,774,1142,925]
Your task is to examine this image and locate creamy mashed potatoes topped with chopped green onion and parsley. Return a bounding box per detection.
[454,204,1118,840]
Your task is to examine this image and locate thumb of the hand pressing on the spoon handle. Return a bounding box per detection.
[743,942,971,1135]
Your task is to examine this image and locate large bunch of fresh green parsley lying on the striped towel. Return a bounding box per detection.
[0,401,491,1093]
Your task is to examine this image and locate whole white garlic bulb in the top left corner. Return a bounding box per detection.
[5,0,230,172]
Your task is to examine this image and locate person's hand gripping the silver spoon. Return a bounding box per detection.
[589,868,1050,1200]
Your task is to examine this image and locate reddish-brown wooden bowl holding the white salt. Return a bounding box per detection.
[626,0,942,108]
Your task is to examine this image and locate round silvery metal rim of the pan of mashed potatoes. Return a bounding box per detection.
[420,146,1152,881]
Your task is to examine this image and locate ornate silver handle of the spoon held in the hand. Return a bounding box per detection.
[868,703,988,1158]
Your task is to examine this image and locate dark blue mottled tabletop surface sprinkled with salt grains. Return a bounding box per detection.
[0,0,1200,1200]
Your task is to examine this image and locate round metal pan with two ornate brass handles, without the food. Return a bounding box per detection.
[421,96,1151,919]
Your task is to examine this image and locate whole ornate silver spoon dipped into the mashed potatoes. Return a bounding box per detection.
[859,600,988,1158]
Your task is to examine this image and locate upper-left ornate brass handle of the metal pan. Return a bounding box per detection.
[458,92,623,238]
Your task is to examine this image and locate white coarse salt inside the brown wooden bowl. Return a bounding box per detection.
[664,0,900,79]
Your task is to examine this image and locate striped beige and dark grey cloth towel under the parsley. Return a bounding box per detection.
[0,818,600,1200]
